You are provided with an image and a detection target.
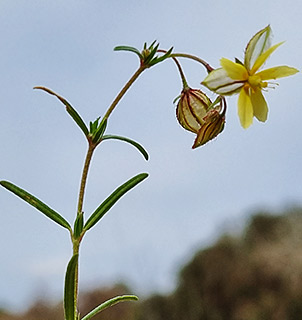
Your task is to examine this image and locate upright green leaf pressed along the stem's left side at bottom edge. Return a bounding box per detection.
[64,254,79,320]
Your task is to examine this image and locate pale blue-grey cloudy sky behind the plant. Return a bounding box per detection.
[0,0,302,310]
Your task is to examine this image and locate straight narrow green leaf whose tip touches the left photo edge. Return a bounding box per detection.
[0,181,71,230]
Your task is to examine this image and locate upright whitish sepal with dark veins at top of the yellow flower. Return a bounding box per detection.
[244,25,272,70]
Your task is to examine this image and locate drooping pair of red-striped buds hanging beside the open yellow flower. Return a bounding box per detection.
[176,87,226,149]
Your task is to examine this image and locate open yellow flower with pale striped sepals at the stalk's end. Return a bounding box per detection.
[202,26,298,128]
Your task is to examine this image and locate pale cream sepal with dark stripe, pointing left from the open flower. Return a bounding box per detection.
[201,68,244,95]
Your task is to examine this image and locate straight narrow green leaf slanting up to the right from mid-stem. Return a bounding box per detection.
[84,173,148,231]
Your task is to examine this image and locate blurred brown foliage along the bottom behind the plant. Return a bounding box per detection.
[0,208,302,320]
